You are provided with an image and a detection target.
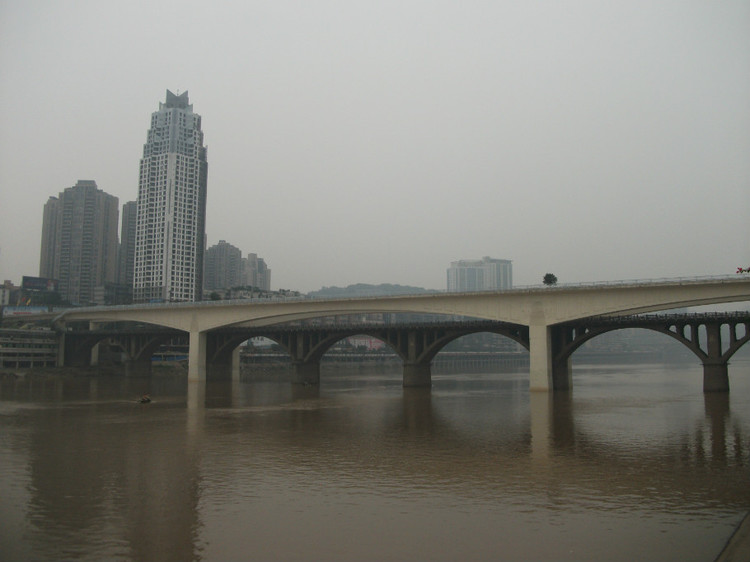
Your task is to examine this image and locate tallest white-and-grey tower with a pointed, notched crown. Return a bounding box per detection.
[133,90,208,302]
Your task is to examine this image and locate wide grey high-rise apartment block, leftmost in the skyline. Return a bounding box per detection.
[39,180,119,304]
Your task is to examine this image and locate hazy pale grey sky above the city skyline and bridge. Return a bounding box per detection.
[0,0,750,291]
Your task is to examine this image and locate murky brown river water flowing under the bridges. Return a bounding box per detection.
[0,360,750,562]
